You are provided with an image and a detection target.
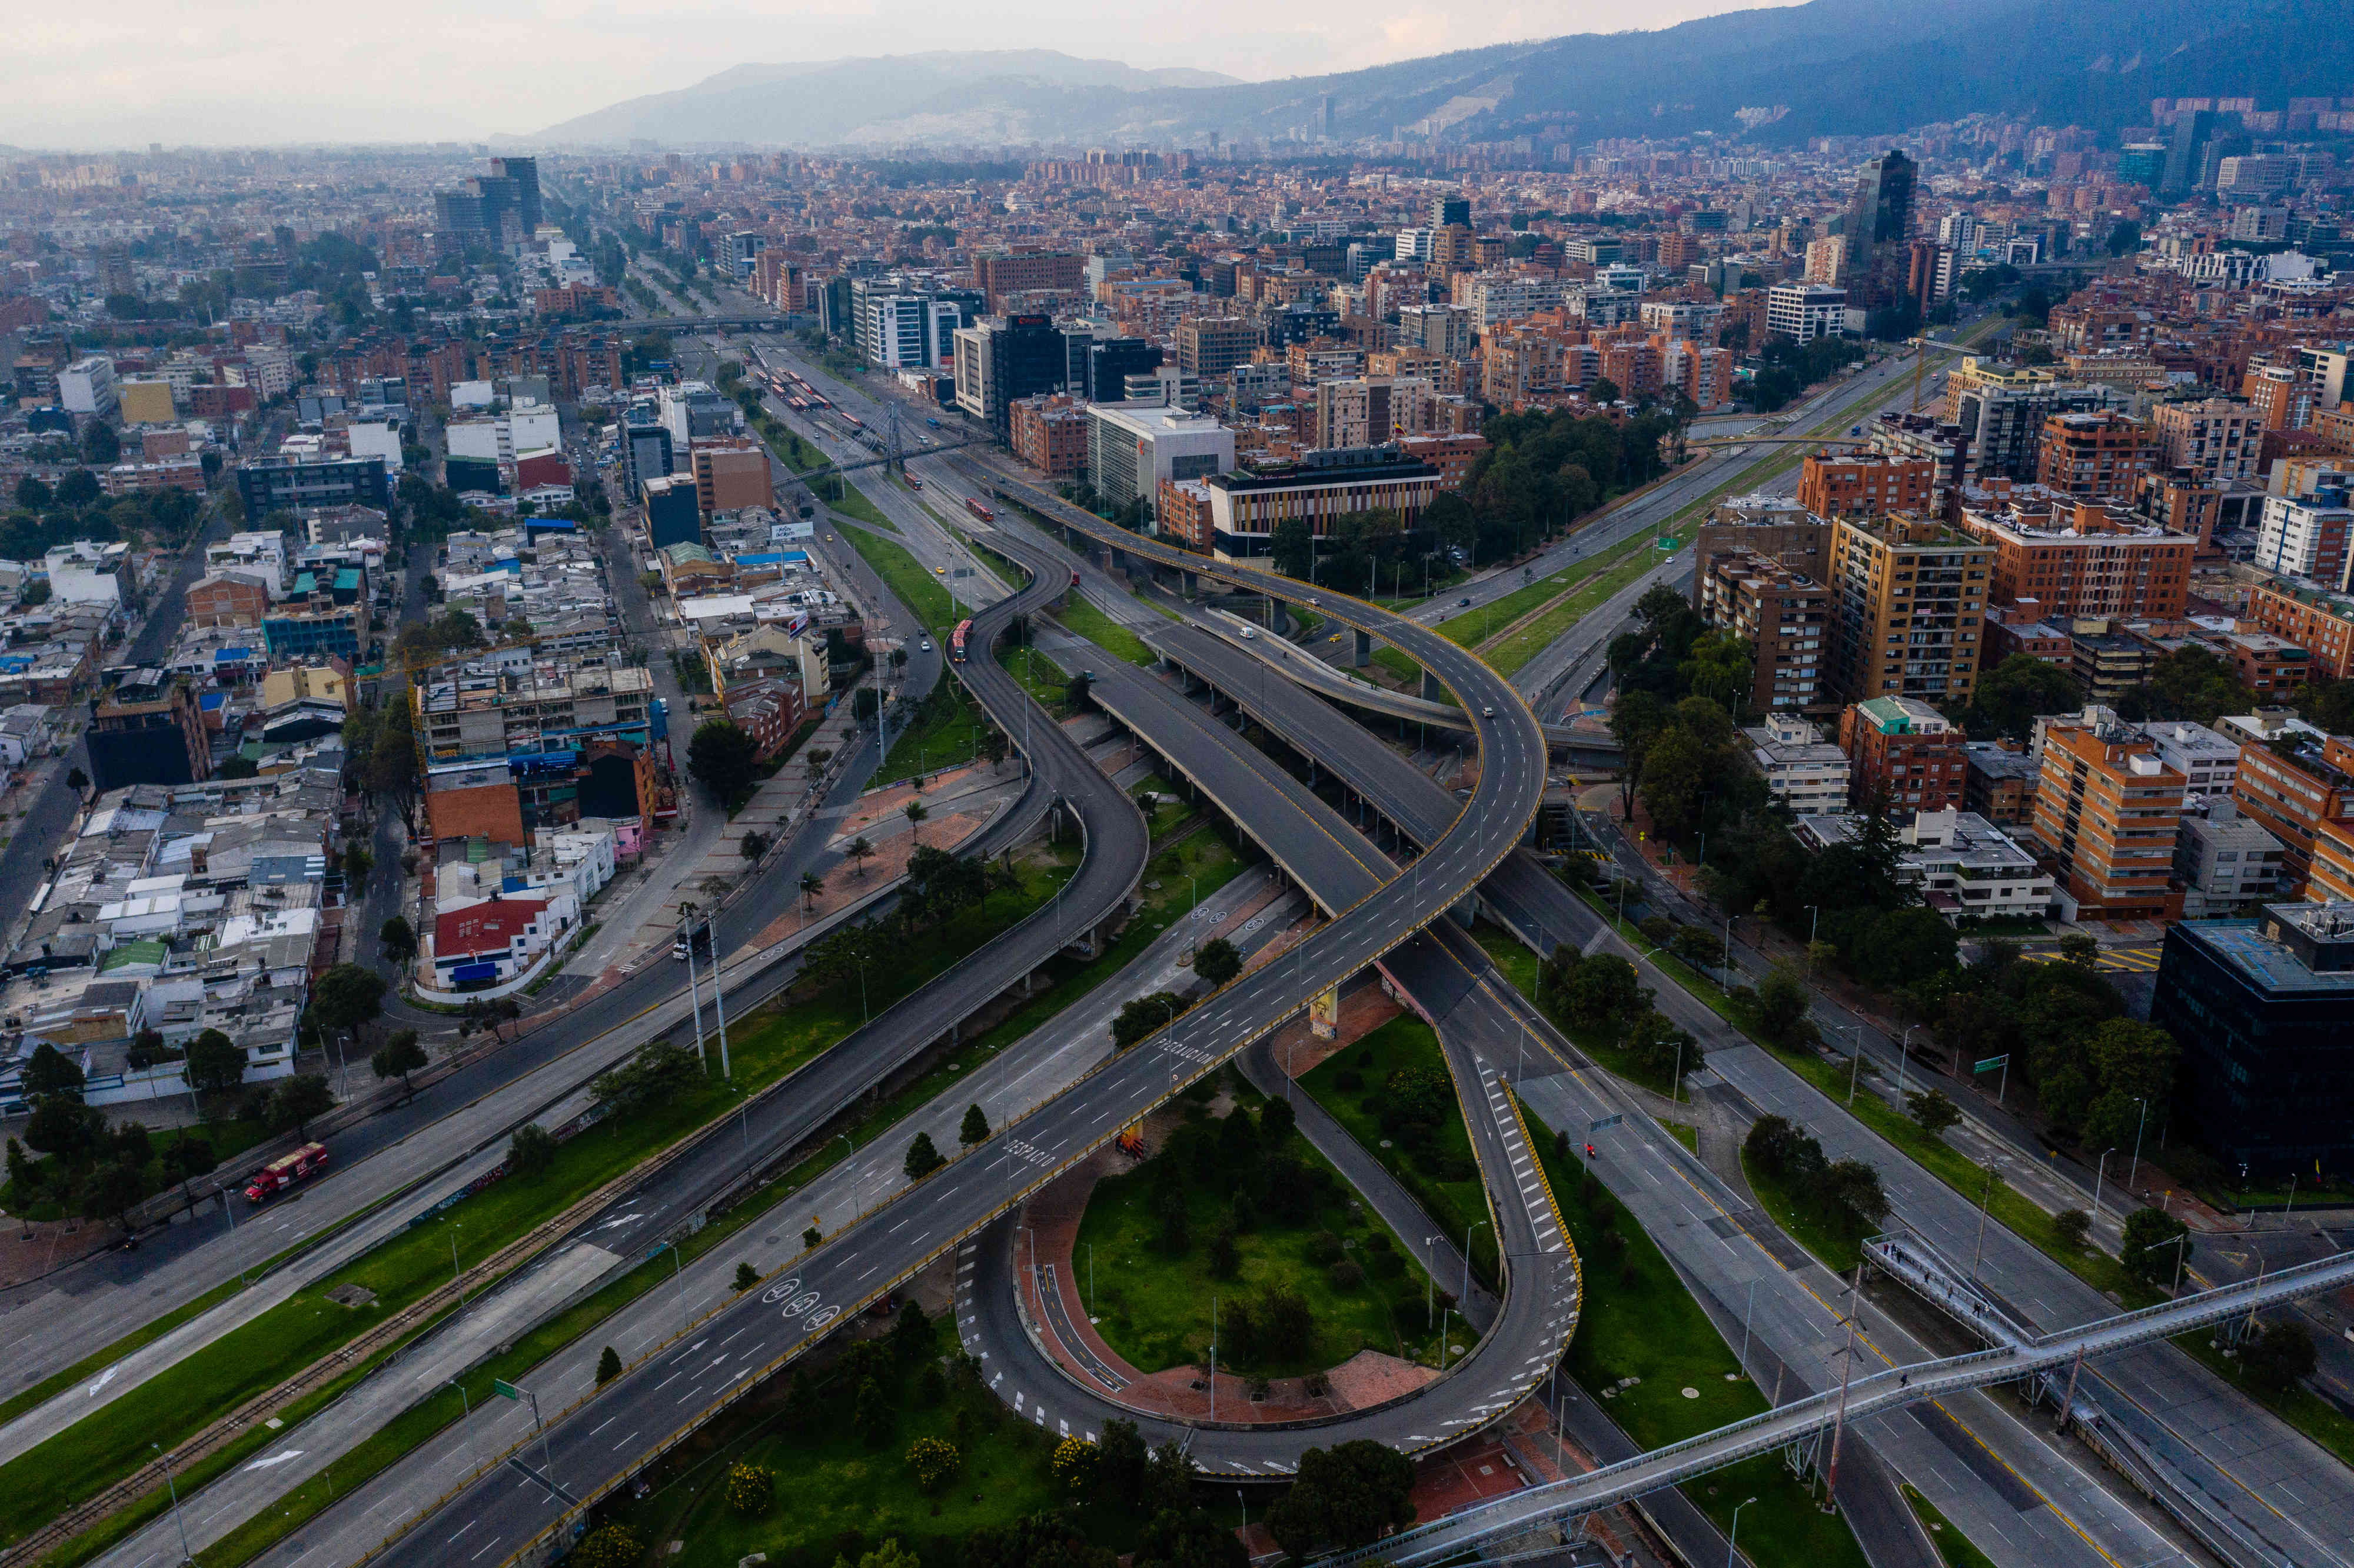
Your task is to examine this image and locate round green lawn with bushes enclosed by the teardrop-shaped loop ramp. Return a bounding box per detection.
[1071,1097,1438,1377]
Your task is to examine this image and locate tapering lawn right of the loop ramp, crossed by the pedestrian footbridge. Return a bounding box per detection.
[1523,1107,1864,1568]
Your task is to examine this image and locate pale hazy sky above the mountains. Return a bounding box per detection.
[0,0,1780,148]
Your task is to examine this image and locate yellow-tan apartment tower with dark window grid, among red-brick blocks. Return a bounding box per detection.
[1831,515,1994,701]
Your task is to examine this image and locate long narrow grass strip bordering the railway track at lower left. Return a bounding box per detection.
[0,874,1050,1544]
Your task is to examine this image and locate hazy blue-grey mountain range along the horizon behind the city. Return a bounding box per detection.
[518,0,2354,148]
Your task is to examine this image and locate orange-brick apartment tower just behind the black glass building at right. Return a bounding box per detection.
[2034,718,2187,921]
